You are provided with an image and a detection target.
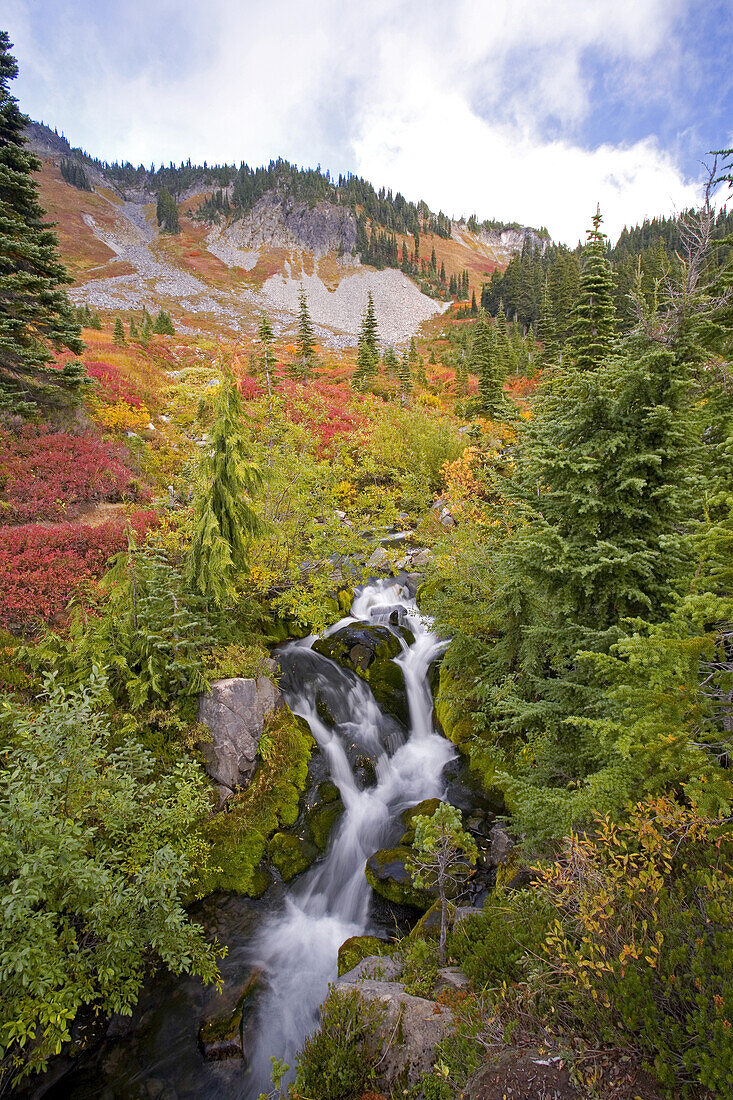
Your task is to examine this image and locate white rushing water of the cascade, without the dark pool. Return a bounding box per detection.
[247,581,455,1096]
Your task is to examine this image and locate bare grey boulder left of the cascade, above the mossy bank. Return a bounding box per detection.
[198,675,282,794]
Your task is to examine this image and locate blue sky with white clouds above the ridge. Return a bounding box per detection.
[0,0,733,244]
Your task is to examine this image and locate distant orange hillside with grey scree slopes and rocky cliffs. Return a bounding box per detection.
[26,123,545,348]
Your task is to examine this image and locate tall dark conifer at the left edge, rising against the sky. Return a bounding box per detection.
[0,31,84,414]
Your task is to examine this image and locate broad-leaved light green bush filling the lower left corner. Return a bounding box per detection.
[0,671,219,1084]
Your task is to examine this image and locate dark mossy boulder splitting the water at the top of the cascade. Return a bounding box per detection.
[313,623,409,725]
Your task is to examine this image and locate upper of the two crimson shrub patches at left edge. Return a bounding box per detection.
[0,427,132,524]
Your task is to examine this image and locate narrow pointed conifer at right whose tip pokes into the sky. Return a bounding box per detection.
[570,208,615,371]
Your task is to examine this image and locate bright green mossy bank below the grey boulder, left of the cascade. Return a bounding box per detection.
[194,707,314,898]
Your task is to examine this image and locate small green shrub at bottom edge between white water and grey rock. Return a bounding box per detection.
[295,986,384,1100]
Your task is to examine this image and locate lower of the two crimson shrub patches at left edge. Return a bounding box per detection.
[0,512,157,630]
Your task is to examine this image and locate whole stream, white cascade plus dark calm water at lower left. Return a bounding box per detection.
[51,581,484,1100]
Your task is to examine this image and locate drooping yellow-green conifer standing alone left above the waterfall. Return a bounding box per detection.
[186,364,262,607]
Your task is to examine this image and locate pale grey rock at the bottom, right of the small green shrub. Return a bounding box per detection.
[335,980,453,1092]
